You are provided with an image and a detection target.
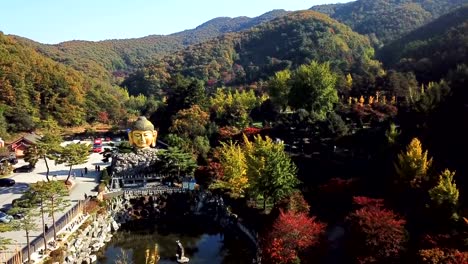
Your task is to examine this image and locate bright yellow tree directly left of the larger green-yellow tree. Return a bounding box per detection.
[210,142,249,197]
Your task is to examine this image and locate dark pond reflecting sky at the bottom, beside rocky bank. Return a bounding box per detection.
[97,218,253,264]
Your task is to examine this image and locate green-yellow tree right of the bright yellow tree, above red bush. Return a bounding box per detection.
[244,135,299,209]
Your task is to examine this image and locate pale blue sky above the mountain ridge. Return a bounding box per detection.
[0,0,349,44]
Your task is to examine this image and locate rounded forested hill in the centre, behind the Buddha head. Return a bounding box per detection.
[124,11,379,97]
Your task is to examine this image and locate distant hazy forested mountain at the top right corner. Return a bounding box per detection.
[311,0,468,46]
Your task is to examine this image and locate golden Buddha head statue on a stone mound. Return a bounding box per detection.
[128,116,158,149]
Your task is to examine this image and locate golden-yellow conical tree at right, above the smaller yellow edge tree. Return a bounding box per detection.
[395,138,432,188]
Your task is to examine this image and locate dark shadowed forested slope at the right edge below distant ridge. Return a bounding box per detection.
[378,6,468,83]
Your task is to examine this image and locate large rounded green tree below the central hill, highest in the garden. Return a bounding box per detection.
[288,61,338,121]
